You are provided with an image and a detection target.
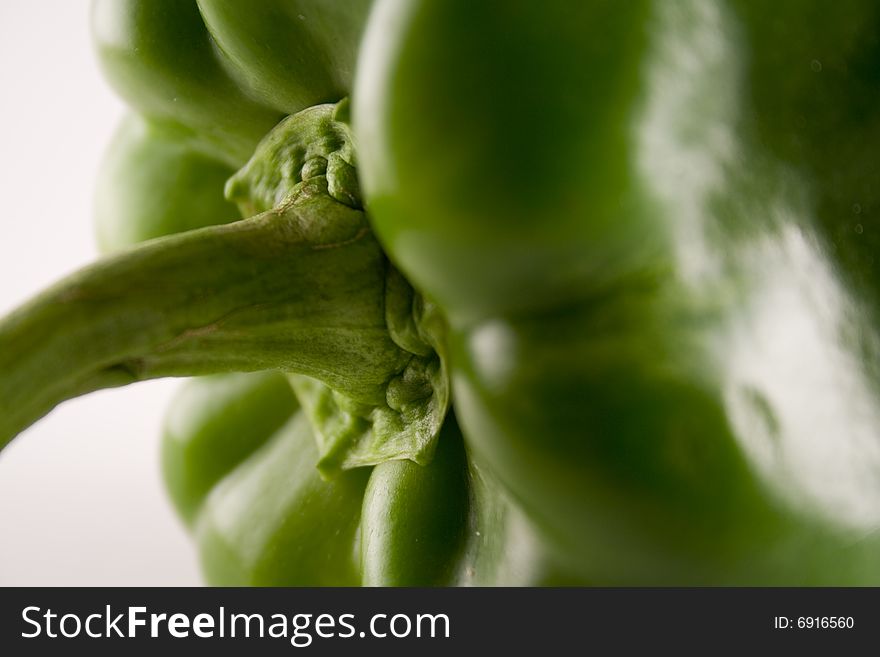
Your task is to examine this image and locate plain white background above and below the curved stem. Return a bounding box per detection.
[0,0,200,586]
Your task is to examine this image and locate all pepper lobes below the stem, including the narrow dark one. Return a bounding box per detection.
[162,372,573,586]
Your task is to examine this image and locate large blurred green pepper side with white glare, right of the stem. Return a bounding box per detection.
[353,0,880,584]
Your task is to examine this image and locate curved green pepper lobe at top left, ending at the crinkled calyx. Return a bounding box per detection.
[91,0,282,167]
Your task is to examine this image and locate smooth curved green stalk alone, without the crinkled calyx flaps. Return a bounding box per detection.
[0,188,402,445]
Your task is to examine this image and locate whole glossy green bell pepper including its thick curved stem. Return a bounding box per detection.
[0,0,880,586]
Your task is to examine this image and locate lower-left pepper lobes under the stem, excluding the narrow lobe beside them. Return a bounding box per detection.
[175,373,369,586]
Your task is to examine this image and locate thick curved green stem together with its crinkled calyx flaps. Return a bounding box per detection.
[0,102,449,475]
